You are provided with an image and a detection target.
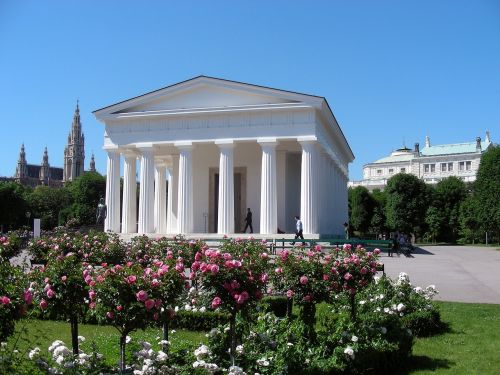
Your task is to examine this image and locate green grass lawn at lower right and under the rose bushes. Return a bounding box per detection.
[3,302,500,375]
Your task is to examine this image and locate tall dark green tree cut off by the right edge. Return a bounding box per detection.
[473,147,500,242]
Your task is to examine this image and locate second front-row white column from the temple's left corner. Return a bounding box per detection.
[138,147,154,234]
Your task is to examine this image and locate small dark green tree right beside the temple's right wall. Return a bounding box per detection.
[348,186,374,233]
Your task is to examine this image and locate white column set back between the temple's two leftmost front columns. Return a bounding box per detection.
[122,153,137,233]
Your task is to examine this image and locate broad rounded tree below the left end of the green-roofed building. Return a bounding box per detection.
[385,173,431,234]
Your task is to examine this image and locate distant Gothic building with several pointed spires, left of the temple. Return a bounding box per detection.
[7,102,95,187]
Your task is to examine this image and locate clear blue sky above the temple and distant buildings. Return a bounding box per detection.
[0,0,500,179]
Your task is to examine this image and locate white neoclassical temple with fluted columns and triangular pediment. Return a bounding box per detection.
[94,76,354,237]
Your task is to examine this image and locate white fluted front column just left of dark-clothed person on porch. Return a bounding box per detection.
[215,140,234,234]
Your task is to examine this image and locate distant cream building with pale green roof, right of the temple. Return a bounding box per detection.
[349,132,493,190]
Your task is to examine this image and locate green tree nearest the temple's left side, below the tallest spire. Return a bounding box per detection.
[67,172,106,225]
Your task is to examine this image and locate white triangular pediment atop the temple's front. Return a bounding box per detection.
[94,76,323,118]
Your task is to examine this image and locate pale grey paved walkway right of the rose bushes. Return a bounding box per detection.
[381,246,500,304]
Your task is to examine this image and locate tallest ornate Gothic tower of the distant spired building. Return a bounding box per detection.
[63,101,85,181]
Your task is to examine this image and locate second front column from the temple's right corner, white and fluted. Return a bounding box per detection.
[258,139,278,234]
